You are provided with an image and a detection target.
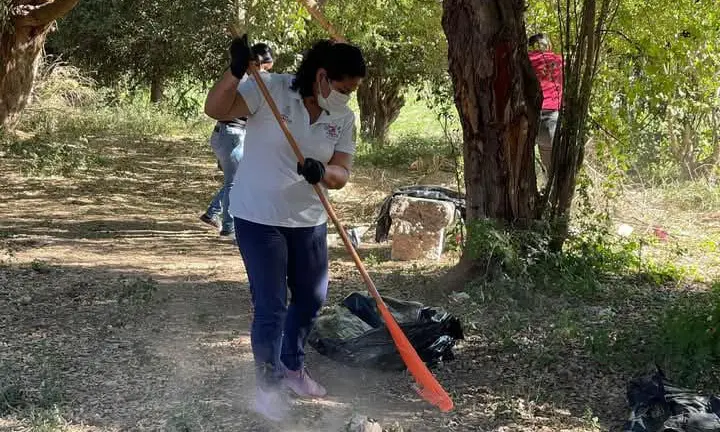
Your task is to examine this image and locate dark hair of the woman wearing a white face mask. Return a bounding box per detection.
[291,40,367,97]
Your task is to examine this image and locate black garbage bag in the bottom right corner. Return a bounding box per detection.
[623,369,720,432]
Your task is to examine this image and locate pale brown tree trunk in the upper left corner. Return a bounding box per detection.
[0,0,78,129]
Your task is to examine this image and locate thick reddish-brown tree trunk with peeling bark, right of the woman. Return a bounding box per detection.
[443,0,541,225]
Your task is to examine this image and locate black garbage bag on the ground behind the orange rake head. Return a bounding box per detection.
[308,293,464,370]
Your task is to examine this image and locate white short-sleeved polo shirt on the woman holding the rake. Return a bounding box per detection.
[229,73,355,228]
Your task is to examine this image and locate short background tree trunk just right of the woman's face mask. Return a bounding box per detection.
[357,75,405,146]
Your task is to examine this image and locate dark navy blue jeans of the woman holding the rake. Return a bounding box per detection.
[235,218,328,386]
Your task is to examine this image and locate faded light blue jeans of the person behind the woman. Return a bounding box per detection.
[205,123,245,233]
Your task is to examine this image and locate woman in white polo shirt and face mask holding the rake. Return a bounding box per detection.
[205,36,366,420]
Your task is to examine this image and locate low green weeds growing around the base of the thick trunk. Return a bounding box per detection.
[465,176,693,299]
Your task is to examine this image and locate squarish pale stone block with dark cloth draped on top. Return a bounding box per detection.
[390,196,455,261]
